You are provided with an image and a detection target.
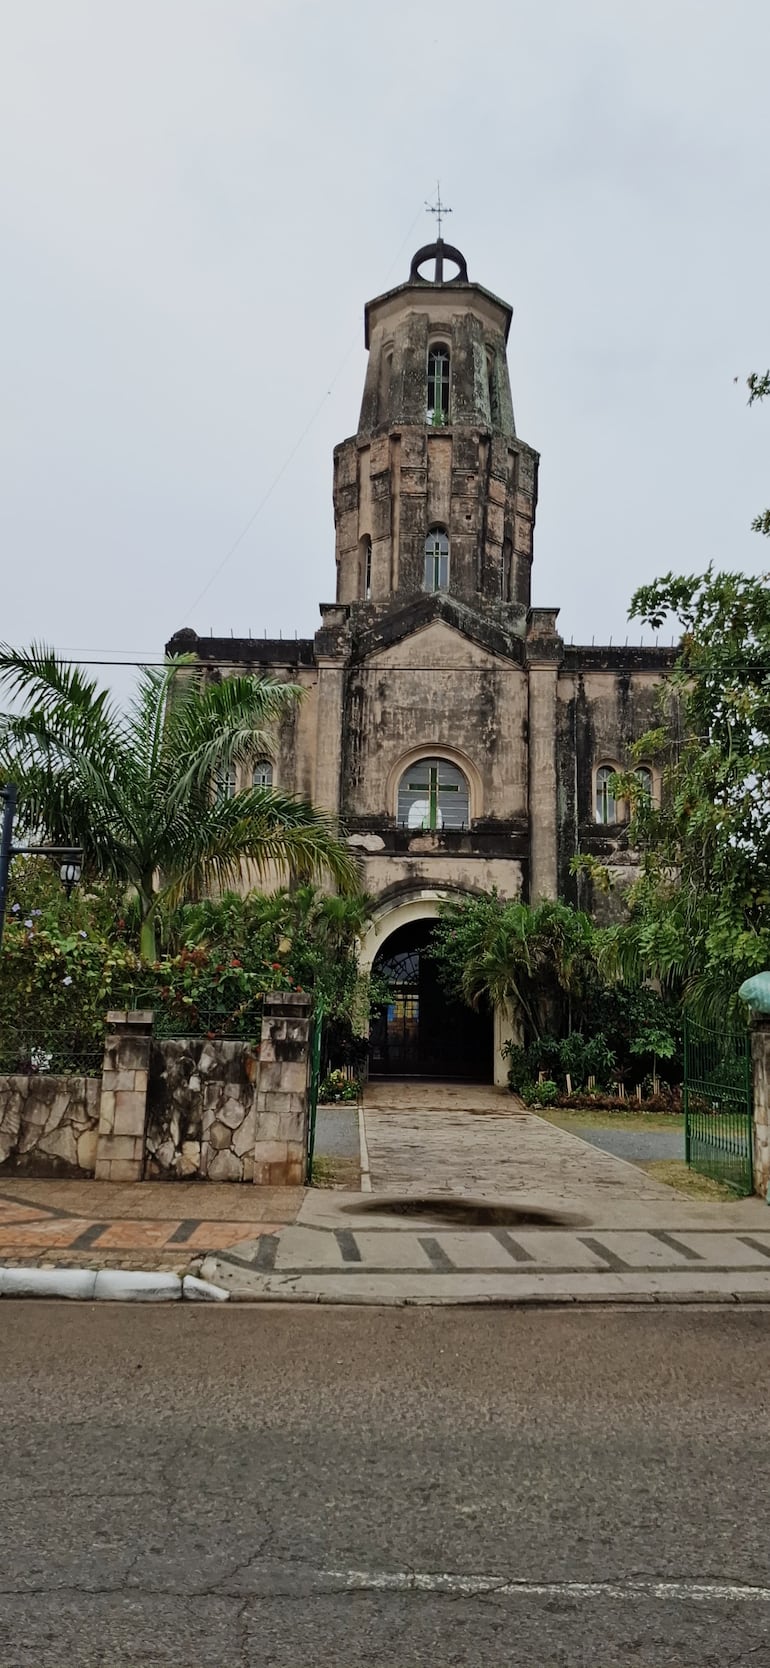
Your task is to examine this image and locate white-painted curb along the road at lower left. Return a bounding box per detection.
[0,1268,230,1303]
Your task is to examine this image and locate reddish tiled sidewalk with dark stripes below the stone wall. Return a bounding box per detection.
[0,1176,303,1268]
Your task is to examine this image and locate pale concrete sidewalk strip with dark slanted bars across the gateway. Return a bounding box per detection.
[196,1194,770,1304]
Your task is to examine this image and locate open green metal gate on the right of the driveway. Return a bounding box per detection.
[683,1019,753,1194]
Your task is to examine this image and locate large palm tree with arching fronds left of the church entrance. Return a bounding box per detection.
[0,644,358,961]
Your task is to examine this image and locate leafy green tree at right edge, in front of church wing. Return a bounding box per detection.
[600,567,770,1014]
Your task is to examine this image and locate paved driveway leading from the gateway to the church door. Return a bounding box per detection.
[363,1081,690,1221]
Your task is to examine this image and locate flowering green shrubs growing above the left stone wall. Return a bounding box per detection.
[0,859,368,1071]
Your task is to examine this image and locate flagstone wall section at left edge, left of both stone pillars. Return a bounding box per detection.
[0,1073,100,1176]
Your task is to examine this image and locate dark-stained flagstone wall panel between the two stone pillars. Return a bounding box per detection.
[145,1037,258,1181]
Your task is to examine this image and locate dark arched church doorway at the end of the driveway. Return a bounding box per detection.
[368,919,493,1083]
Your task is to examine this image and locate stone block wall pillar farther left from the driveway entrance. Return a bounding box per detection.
[95,1009,152,1181]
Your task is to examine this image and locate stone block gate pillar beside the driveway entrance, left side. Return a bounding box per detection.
[253,991,312,1188]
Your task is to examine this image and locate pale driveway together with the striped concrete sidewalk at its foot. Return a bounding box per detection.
[202,1083,770,1304]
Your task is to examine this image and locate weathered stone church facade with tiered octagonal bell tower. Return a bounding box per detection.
[167,240,673,1078]
